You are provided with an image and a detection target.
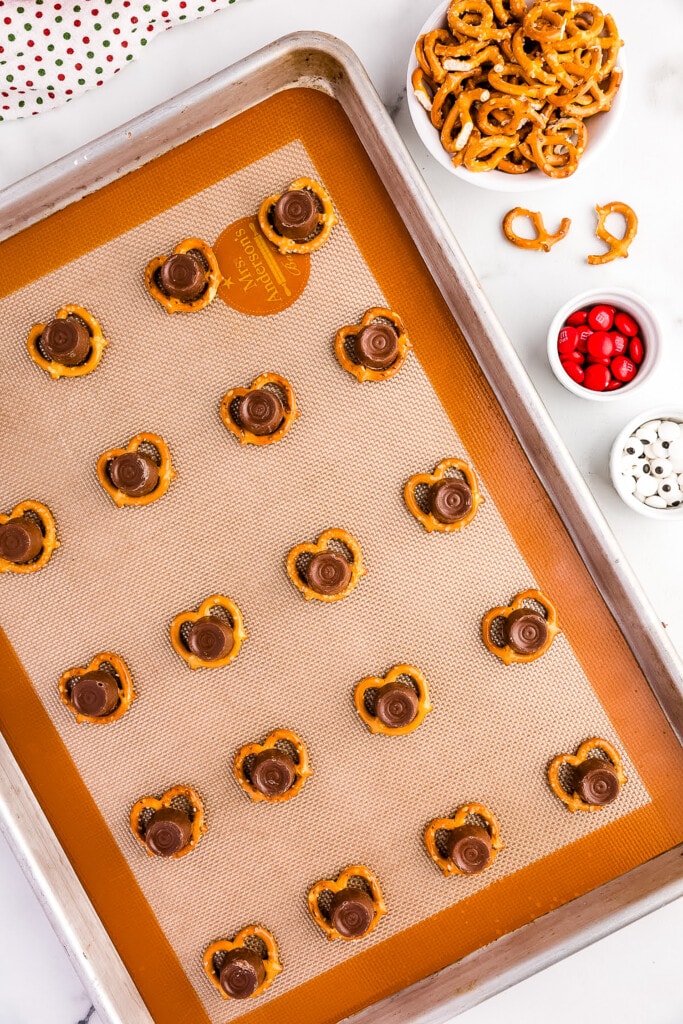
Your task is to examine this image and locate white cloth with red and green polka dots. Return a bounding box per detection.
[0,0,236,121]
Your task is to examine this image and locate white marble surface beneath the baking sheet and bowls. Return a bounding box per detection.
[0,0,683,1024]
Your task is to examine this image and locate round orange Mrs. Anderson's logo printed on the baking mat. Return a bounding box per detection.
[213,217,310,316]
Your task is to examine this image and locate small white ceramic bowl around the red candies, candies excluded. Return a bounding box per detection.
[548,288,661,401]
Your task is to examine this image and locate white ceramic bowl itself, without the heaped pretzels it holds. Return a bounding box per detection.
[408,0,627,193]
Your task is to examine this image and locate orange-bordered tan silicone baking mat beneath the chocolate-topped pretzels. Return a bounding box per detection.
[0,90,683,1024]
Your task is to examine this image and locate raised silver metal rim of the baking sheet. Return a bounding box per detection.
[0,33,683,1024]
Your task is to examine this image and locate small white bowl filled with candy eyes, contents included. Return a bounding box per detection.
[609,409,683,519]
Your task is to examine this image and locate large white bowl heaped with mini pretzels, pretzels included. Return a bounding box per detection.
[408,0,625,191]
